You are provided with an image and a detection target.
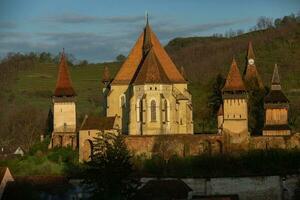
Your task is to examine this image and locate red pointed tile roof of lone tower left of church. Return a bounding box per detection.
[54,52,76,97]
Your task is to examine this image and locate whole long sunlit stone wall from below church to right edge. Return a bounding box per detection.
[125,133,300,156]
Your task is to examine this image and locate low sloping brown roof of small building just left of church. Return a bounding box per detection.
[80,116,116,130]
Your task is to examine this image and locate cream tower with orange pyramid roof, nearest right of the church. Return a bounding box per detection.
[222,59,248,138]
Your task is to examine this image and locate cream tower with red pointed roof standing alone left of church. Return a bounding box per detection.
[50,51,77,148]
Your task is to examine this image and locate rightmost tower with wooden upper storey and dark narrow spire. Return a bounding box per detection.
[263,64,291,136]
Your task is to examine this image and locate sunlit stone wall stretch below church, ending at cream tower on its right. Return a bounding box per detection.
[125,134,224,156]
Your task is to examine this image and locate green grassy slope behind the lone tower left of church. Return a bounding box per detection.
[8,63,119,115]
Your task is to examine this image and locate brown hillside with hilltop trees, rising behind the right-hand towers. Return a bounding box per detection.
[166,16,300,132]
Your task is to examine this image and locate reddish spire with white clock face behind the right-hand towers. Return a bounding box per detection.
[244,41,264,89]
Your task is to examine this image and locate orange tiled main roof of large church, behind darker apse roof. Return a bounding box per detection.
[112,22,186,84]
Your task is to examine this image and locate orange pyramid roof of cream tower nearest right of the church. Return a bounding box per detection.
[222,59,246,92]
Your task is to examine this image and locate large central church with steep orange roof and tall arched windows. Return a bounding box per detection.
[106,15,193,135]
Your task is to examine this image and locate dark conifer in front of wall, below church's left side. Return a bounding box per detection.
[84,133,138,199]
